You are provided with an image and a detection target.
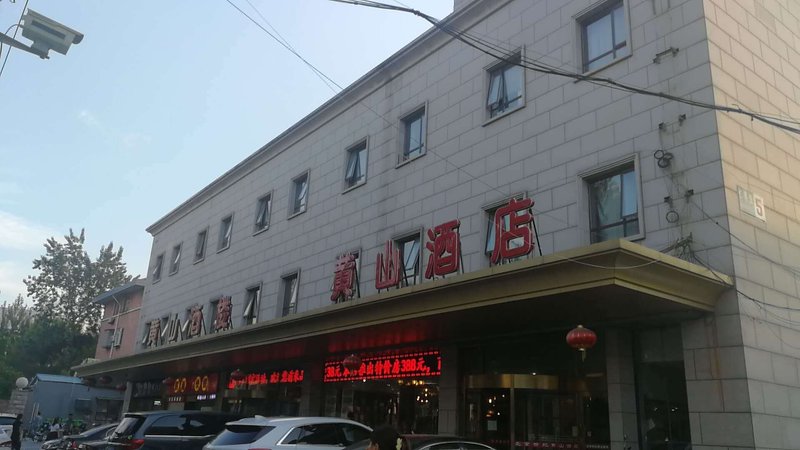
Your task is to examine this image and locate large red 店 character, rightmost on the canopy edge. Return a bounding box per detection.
[491,198,533,264]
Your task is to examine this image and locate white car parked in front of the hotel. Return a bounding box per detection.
[203,416,372,450]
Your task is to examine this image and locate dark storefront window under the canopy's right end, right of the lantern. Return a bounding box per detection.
[636,327,692,450]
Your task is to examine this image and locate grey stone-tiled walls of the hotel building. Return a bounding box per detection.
[138,0,800,449]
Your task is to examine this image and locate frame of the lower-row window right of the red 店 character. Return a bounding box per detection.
[578,154,645,245]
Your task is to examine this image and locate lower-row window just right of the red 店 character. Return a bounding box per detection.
[587,165,640,243]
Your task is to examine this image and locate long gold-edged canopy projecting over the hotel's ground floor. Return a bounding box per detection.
[74,240,732,380]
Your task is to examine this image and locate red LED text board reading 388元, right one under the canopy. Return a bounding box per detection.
[323,351,442,383]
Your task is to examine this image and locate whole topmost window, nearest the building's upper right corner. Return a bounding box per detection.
[580,0,630,72]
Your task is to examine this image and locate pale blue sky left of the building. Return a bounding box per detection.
[0,0,453,303]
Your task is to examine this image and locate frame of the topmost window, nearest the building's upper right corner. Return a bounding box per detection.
[574,0,632,74]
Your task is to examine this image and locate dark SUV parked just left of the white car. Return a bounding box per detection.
[107,411,242,450]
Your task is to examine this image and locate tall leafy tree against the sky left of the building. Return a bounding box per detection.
[24,229,131,336]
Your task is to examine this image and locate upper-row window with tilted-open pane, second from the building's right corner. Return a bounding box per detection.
[486,53,525,118]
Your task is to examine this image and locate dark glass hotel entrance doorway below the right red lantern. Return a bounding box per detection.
[465,374,608,450]
